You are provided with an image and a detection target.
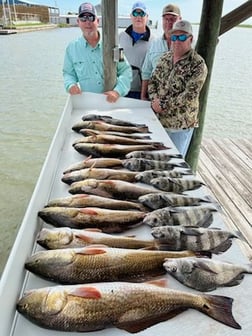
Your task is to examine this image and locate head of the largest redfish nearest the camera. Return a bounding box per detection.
[17,286,67,325]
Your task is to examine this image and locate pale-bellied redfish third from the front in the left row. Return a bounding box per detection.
[37,227,155,250]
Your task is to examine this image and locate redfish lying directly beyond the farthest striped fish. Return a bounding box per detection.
[73,143,166,158]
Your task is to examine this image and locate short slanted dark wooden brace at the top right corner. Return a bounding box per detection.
[219,0,252,35]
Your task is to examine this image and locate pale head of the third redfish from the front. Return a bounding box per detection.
[37,227,74,249]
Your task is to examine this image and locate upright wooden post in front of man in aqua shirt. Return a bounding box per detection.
[102,0,118,91]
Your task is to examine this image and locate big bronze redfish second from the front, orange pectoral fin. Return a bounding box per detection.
[25,245,199,284]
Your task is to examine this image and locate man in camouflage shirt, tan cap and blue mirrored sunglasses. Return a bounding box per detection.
[148,20,207,157]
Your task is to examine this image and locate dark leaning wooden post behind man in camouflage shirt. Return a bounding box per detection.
[186,0,224,172]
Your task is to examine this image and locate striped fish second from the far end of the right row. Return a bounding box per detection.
[122,159,188,172]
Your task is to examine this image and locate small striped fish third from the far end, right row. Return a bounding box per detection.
[136,169,192,184]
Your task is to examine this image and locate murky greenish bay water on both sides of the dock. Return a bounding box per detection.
[0,27,252,274]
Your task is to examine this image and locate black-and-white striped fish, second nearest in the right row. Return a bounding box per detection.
[151,226,239,254]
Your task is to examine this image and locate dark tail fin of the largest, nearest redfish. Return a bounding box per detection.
[200,295,241,329]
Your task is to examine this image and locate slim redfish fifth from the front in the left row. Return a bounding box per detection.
[46,194,146,211]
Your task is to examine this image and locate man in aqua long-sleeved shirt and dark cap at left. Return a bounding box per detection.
[63,2,132,102]
